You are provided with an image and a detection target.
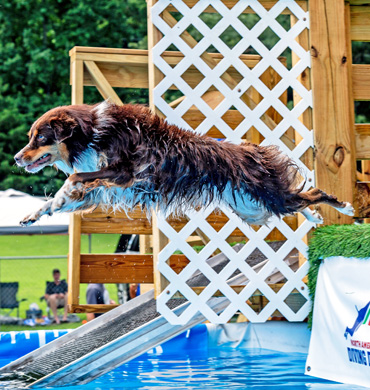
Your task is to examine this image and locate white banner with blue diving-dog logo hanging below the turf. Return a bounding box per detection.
[306,257,370,387]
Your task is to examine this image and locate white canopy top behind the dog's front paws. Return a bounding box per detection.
[0,189,69,235]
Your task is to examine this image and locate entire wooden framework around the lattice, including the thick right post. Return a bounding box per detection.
[68,0,370,312]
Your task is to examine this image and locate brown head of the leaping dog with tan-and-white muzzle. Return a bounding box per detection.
[14,106,92,173]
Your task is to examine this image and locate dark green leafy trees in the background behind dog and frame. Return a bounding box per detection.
[0,0,370,195]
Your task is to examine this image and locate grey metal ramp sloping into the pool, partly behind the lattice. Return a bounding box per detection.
[0,243,297,388]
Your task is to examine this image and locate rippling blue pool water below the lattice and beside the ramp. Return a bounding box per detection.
[0,325,364,390]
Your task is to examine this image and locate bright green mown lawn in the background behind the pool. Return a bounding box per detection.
[0,234,119,331]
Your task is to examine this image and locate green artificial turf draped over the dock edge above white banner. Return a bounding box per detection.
[308,224,370,327]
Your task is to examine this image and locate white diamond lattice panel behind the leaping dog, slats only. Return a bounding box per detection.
[151,0,314,324]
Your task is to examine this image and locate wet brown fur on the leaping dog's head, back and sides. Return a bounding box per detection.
[14,103,345,216]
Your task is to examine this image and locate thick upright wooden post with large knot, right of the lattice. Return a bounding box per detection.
[310,0,356,224]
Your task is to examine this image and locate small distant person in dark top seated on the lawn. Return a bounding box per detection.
[44,269,68,324]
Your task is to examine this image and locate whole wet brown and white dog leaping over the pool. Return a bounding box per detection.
[15,101,353,226]
